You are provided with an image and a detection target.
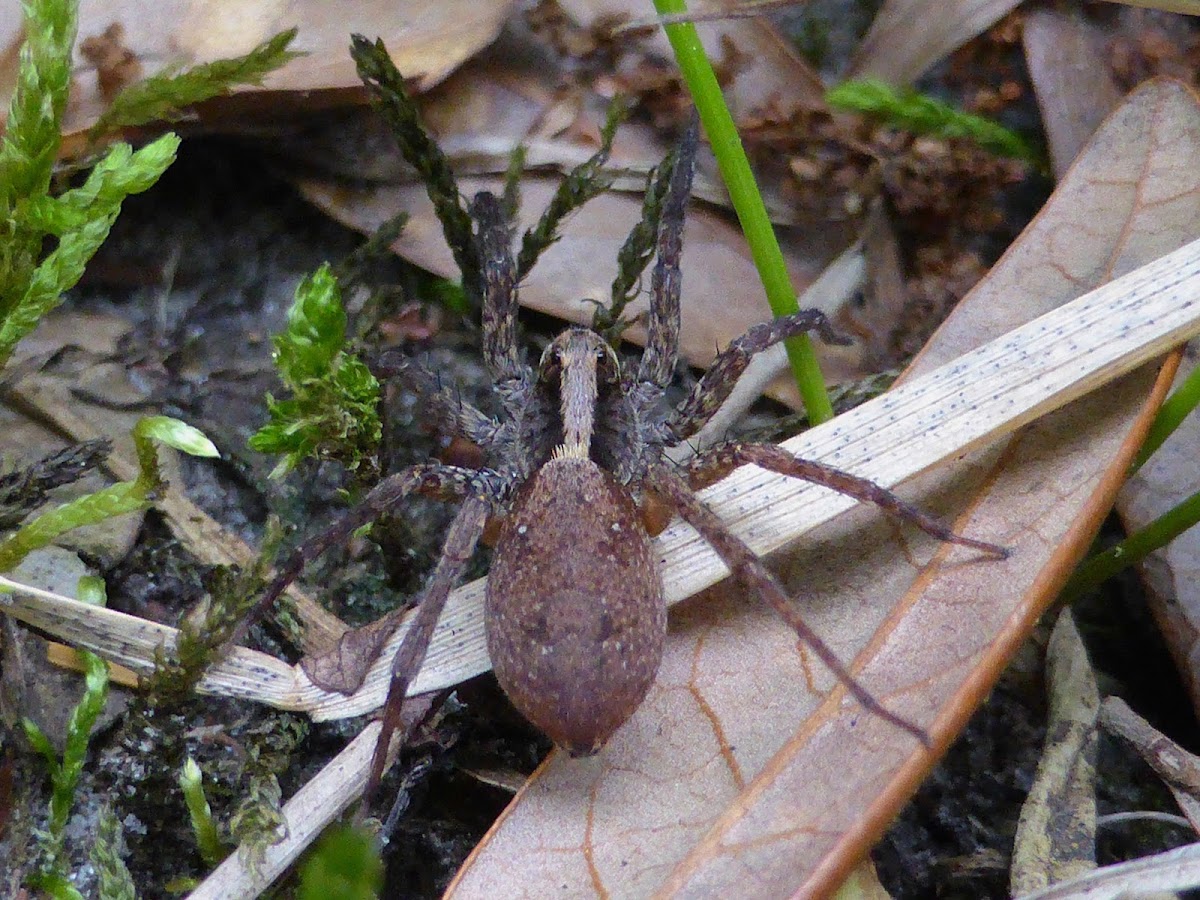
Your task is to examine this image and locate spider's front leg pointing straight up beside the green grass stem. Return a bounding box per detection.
[637,114,700,389]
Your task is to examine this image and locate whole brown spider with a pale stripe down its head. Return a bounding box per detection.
[241,114,1004,805]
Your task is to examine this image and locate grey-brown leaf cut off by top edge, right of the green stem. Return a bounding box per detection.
[846,0,1020,84]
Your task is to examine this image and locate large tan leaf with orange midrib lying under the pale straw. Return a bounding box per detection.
[451,82,1200,898]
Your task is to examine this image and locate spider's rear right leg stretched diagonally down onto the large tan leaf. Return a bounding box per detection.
[648,464,931,746]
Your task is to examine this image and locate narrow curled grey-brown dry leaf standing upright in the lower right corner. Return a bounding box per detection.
[1009,610,1100,895]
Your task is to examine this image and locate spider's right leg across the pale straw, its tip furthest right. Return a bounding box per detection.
[688,442,1008,559]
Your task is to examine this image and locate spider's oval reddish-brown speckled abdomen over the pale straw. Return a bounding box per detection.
[486,457,666,756]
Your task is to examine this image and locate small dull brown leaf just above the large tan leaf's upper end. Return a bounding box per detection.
[1021,6,1121,178]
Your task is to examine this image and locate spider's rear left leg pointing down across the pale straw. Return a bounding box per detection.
[359,496,492,816]
